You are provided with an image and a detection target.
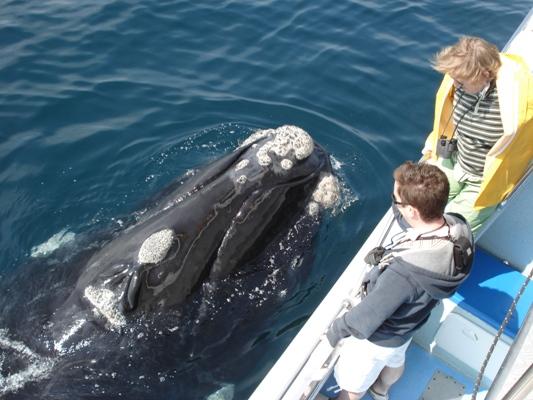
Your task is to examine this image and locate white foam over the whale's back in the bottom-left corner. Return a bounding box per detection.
[0,329,54,396]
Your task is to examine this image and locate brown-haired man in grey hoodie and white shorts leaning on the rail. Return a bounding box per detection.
[327,162,473,400]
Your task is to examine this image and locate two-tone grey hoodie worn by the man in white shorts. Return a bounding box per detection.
[327,214,473,347]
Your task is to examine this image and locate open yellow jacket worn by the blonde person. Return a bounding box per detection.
[422,54,533,209]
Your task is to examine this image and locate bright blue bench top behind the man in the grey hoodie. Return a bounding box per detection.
[451,247,533,338]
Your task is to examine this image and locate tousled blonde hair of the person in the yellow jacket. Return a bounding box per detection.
[432,36,502,81]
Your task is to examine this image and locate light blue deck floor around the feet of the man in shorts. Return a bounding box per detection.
[321,343,474,400]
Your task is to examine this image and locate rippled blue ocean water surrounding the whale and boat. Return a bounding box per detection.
[0,0,531,399]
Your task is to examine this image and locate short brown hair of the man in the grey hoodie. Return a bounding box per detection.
[394,161,450,221]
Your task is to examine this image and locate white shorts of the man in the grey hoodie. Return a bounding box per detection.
[334,336,411,393]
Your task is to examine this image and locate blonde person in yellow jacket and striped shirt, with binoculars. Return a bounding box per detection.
[422,36,533,235]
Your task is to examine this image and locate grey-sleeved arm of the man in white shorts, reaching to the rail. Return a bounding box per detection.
[327,267,413,346]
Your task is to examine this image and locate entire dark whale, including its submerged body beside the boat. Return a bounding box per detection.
[0,125,340,399]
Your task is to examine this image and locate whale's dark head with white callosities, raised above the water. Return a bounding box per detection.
[63,125,339,327]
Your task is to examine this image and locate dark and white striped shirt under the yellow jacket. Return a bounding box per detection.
[453,86,503,176]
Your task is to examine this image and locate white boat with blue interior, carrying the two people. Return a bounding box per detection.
[250,9,533,400]
